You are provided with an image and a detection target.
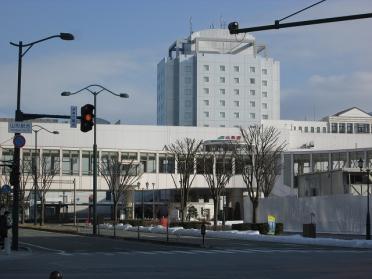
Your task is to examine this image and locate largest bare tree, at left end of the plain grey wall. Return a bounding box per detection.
[236,125,285,223]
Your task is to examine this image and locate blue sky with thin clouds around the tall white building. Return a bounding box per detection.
[0,0,372,125]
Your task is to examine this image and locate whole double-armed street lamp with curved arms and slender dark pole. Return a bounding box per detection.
[61,84,129,235]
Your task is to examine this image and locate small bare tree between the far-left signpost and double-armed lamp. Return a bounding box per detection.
[37,156,59,225]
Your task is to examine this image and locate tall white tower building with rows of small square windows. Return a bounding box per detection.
[157,29,280,127]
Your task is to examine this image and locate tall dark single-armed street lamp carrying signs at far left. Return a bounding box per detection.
[10,33,74,250]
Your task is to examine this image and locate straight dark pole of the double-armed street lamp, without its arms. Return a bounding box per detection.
[93,93,98,235]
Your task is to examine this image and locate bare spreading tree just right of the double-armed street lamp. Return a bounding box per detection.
[99,156,143,230]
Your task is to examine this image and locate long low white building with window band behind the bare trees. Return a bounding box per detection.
[0,108,372,223]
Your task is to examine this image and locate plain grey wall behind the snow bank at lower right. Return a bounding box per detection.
[244,195,367,234]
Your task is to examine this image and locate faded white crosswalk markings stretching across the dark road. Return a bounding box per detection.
[57,249,372,257]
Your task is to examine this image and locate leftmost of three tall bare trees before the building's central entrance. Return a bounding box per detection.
[165,138,203,222]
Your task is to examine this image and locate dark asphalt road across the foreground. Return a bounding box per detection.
[0,230,372,279]
